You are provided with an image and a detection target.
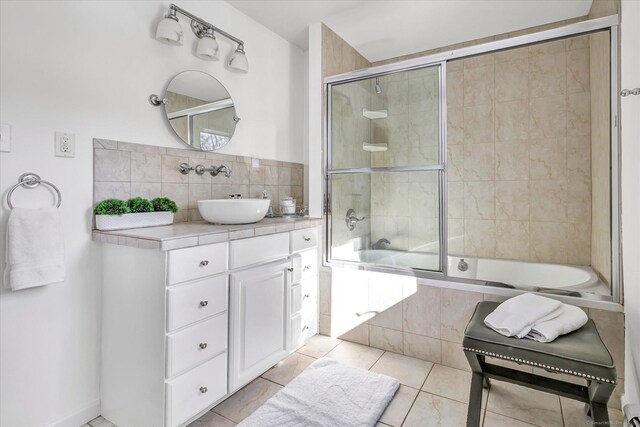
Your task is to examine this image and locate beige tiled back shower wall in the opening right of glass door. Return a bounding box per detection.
[447,36,591,265]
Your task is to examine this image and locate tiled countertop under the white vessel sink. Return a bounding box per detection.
[93,217,322,251]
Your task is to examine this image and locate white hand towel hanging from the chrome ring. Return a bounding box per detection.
[4,208,65,291]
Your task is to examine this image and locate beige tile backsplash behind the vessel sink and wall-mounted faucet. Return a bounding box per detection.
[93,139,304,222]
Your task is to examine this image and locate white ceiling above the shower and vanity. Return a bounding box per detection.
[227,0,592,62]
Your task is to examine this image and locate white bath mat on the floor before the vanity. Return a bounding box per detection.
[239,358,400,427]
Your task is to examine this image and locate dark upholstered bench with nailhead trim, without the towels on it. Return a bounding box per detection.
[462,301,616,427]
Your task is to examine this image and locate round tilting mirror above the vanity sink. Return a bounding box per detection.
[164,71,240,151]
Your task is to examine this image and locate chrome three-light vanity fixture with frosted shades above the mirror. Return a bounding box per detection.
[156,4,249,73]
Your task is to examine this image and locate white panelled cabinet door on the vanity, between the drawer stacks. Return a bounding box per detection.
[229,261,291,392]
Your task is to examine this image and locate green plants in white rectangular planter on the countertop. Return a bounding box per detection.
[93,197,178,231]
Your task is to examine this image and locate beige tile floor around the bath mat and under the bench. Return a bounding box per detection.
[95,335,623,427]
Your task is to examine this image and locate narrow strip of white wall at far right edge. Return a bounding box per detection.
[620,1,640,414]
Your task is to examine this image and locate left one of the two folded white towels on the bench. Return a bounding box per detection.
[484,293,562,338]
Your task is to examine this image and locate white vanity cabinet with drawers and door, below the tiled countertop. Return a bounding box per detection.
[101,224,319,427]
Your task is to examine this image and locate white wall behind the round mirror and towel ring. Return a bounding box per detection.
[0,1,306,427]
